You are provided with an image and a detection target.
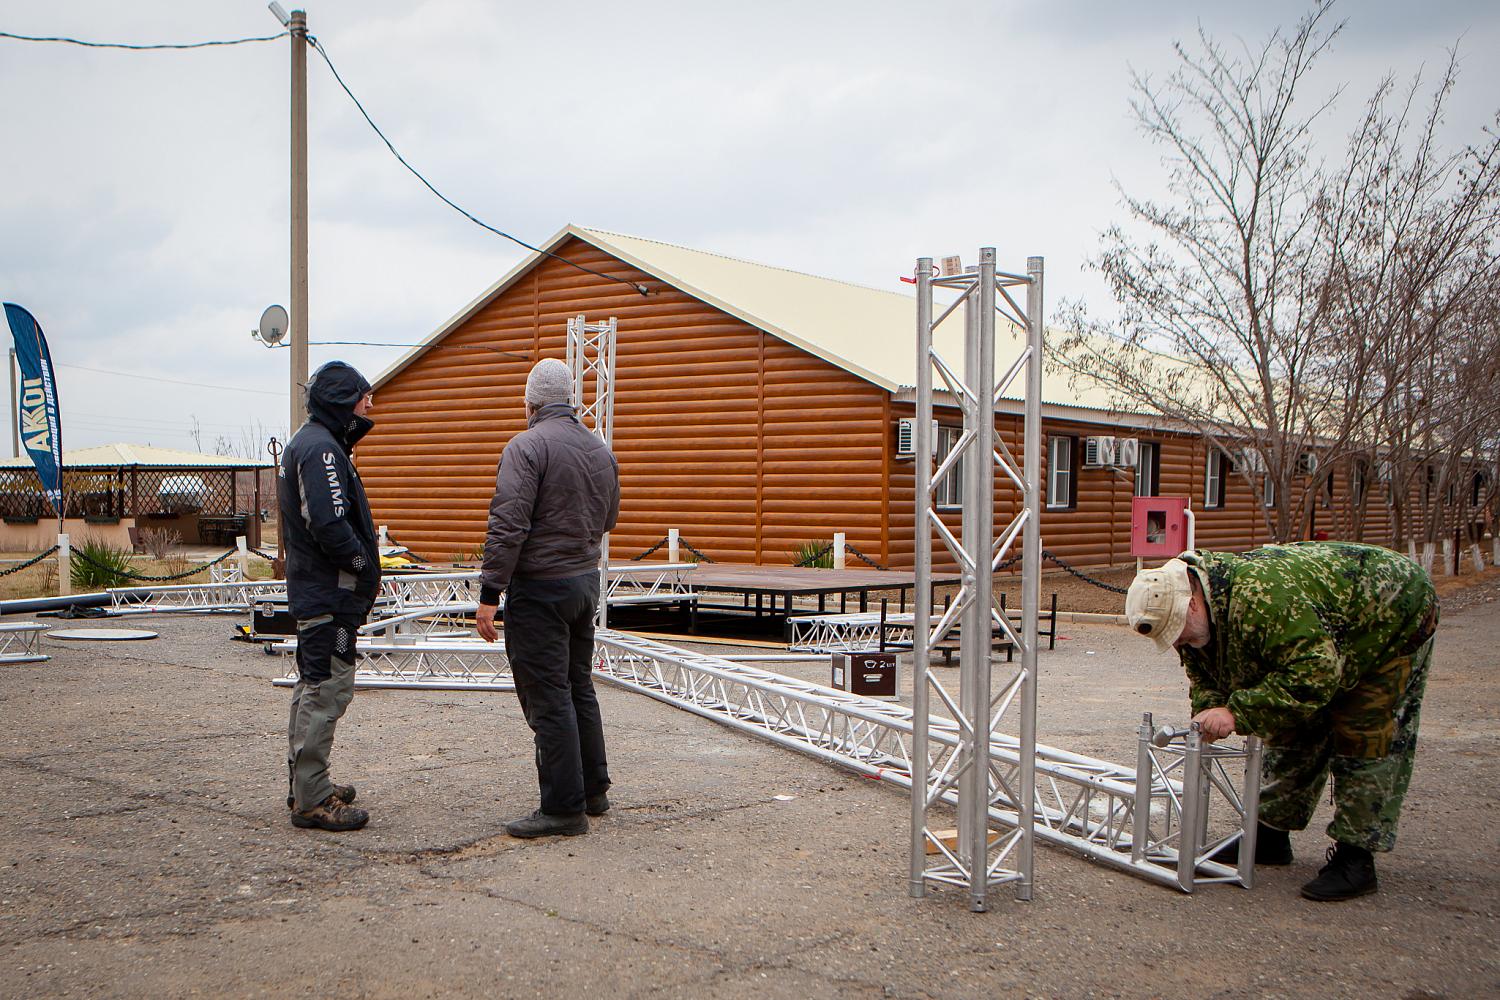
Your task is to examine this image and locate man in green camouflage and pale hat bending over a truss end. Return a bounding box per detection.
[1127,541,1439,900]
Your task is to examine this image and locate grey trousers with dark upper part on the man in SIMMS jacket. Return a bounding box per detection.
[287,615,359,811]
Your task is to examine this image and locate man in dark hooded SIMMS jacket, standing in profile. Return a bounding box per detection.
[276,361,380,831]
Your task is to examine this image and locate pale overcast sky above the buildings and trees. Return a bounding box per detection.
[0,0,1500,451]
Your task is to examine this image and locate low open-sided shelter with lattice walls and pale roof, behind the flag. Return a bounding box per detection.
[0,444,273,552]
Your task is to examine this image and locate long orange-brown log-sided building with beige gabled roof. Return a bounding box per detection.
[357,226,1389,568]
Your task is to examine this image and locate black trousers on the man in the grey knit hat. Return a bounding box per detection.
[506,573,609,816]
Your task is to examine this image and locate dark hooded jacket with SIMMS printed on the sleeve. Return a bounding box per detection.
[276,361,380,619]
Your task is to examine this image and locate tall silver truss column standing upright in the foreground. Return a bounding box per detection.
[911,247,1043,910]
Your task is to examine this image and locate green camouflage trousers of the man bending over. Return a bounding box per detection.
[1260,639,1433,850]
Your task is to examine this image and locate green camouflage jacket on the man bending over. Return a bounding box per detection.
[1181,541,1437,739]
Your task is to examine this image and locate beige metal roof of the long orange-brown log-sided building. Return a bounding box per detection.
[375,225,1128,409]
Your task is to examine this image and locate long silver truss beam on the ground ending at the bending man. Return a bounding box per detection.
[596,631,1260,892]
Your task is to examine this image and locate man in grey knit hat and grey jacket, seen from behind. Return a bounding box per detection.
[476,358,620,837]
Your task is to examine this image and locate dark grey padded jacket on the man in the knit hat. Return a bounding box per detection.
[480,403,620,604]
